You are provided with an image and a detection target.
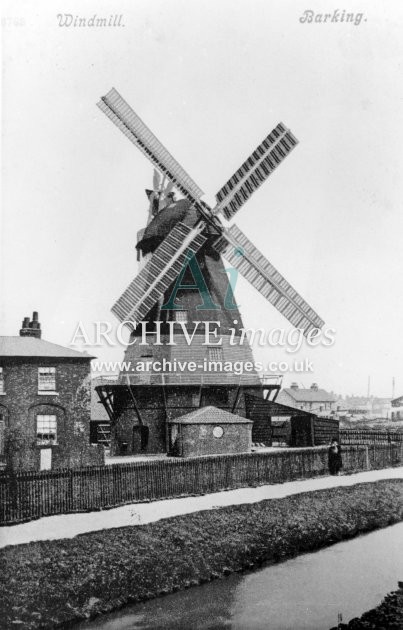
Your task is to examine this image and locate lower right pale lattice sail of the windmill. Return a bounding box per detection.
[215,225,324,336]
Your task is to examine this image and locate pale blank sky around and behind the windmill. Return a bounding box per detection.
[0,0,403,396]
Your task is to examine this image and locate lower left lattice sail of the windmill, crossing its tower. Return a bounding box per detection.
[112,223,206,322]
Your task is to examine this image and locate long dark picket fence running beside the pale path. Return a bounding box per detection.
[0,444,403,525]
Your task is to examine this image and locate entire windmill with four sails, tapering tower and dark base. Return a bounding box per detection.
[98,89,324,453]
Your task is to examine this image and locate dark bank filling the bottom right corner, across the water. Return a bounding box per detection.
[332,588,403,630]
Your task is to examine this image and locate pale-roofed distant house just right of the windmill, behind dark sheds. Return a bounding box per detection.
[276,383,336,416]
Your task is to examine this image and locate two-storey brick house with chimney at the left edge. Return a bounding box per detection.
[0,313,103,470]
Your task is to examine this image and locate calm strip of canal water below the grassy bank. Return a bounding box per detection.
[76,523,403,630]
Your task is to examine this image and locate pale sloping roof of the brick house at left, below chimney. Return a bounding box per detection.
[0,337,94,360]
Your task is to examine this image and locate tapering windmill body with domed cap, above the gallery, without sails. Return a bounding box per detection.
[120,200,260,386]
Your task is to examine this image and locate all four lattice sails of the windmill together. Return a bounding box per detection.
[98,88,324,344]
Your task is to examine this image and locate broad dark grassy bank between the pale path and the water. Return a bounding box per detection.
[0,480,403,628]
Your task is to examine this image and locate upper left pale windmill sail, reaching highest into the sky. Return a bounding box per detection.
[97,88,204,201]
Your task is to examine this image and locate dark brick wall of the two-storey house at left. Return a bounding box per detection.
[0,358,101,470]
